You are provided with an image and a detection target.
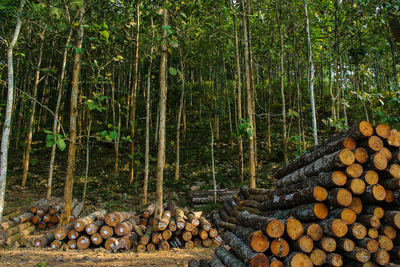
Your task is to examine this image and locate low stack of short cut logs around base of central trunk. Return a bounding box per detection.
[34,202,222,252]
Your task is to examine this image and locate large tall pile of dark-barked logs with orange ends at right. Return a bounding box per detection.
[200,121,400,266]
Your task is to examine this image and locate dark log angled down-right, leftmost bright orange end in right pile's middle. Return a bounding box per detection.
[237,211,285,238]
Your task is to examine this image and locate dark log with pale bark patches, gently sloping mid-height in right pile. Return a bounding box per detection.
[260,186,328,211]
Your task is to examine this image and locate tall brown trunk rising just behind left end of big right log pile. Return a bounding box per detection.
[242,0,256,188]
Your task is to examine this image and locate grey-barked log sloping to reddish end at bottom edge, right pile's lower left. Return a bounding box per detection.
[223,231,268,266]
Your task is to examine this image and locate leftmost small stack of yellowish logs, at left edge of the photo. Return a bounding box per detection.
[0,197,83,246]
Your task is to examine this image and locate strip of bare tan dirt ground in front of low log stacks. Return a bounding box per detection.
[0,248,213,267]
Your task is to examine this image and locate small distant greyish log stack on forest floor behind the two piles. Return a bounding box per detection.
[189,189,239,205]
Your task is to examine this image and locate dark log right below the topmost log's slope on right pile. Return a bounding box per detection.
[275,148,355,186]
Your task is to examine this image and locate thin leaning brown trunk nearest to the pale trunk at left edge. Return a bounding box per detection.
[22,27,46,187]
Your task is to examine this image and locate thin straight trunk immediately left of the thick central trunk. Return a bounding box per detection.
[143,17,154,204]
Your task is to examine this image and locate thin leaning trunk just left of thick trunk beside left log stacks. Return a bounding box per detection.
[47,30,72,199]
